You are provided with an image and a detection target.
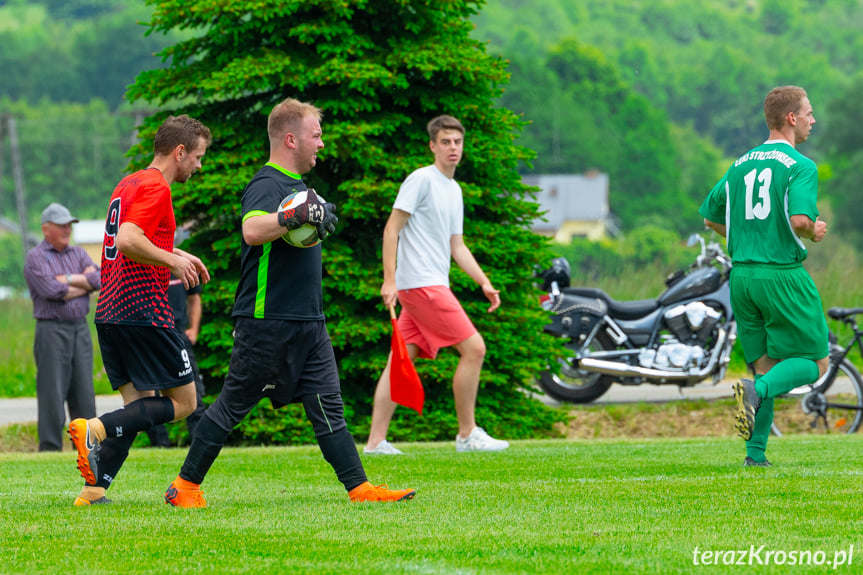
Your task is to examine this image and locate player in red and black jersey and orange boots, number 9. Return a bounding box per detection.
[69,115,211,506]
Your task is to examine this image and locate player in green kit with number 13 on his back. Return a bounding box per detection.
[699,86,829,467]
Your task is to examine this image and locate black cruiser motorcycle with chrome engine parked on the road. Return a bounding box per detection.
[539,234,737,403]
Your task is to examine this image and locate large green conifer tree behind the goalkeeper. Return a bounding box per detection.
[129,0,556,442]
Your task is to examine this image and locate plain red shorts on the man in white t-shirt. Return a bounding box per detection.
[398,286,477,359]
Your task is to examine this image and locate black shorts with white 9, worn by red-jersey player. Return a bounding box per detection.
[96,323,194,391]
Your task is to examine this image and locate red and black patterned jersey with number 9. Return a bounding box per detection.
[95,168,177,329]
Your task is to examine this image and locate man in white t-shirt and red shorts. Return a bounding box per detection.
[363,116,509,455]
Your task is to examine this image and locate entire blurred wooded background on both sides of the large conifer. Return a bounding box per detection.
[5,0,863,238]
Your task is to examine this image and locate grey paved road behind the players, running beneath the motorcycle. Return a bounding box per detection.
[0,377,852,425]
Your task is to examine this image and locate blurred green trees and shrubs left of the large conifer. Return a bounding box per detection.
[0,0,183,232]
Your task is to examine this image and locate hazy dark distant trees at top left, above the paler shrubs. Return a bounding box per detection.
[0,0,183,110]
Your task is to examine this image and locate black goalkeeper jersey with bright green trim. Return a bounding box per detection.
[233,164,324,321]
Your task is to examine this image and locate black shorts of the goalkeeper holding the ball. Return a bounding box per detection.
[207,317,341,430]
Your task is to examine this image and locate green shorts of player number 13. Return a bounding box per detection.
[729,264,830,363]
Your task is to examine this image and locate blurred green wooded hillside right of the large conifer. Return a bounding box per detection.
[474,0,863,241]
